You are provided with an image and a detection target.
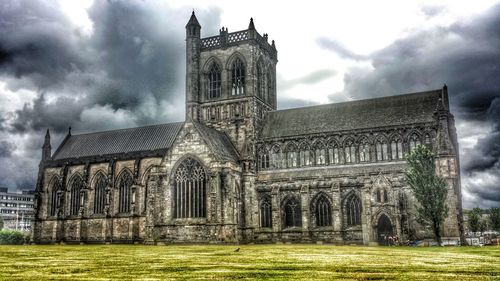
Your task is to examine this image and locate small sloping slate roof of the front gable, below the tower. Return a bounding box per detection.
[193,122,239,162]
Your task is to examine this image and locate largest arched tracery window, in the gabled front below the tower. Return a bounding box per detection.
[173,158,207,218]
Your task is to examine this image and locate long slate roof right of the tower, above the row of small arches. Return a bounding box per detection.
[261,90,442,138]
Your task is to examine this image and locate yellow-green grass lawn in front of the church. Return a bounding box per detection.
[0,245,500,281]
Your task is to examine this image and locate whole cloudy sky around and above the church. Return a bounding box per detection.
[0,0,500,208]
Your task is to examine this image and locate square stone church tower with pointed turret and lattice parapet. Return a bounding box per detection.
[186,12,278,157]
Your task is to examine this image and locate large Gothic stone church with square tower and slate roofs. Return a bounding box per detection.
[33,12,462,244]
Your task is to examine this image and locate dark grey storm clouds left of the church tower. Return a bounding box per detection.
[0,0,220,188]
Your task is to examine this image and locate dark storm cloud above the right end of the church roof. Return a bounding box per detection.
[320,5,500,207]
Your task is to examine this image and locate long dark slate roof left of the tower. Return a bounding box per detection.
[52,122,184,160]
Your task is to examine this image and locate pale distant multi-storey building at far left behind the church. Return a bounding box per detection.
[0,187,35,231]
